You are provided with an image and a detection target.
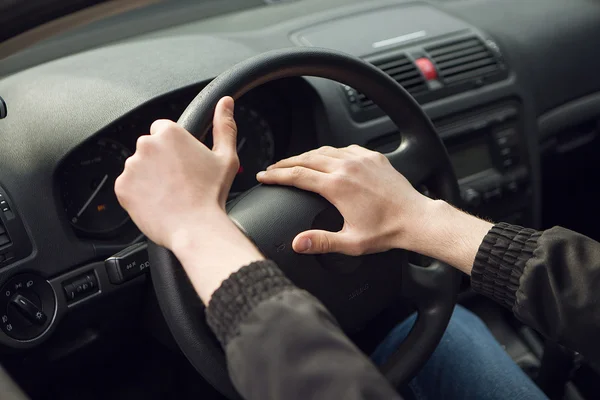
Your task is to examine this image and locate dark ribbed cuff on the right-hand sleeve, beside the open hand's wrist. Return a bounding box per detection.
[471,223,542,309]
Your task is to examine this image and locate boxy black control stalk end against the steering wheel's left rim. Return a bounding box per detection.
[104,243,150,285]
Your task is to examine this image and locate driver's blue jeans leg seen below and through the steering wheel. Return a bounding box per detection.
[372,306,547,400]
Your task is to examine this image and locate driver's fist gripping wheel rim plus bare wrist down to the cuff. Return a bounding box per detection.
[115,97,263,303]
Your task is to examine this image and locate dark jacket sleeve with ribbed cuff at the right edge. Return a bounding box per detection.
[471,223,600,361]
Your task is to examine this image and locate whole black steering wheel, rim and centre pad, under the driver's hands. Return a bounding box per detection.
[148,48,458,399]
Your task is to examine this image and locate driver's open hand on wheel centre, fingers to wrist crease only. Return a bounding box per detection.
[258,145,432,255]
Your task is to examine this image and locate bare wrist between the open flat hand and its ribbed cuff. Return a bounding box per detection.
[405,200,493,275]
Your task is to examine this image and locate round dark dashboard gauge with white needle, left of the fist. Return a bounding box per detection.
[60,139,131,235]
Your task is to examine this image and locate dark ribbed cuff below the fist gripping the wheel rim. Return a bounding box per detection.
[206,260,294,347]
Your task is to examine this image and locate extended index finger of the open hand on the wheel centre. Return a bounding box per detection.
[256,167,330,198]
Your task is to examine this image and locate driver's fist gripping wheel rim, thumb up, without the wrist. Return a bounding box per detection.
[115,99,239,249]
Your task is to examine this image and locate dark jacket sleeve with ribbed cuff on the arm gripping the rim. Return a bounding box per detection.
[207,261,400,400]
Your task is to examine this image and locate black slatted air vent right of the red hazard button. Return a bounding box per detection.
[425,36,501,85]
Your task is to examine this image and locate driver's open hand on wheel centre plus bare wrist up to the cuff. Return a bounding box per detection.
[257,145,492,273]
